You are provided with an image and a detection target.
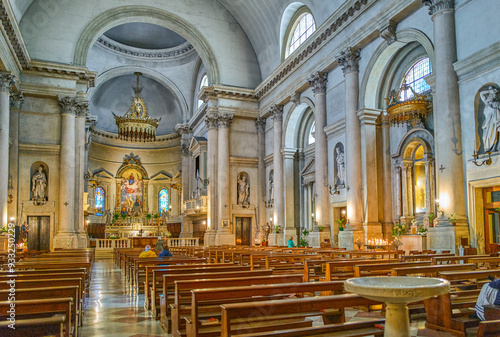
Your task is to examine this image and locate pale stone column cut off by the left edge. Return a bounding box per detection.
[0,73,14,227]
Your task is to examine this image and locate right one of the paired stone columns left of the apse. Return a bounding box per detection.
[75,101,88,248]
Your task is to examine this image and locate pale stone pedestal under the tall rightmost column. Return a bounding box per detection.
[427,225,469,254]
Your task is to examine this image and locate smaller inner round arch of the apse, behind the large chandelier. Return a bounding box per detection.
[88,66,191,122]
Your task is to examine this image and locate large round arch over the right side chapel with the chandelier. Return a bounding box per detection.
[359,28,435,109]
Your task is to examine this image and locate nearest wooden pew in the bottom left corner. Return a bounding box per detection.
[0,297,73,336]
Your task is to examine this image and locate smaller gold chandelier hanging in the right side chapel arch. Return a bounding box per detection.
[384,81,429,126]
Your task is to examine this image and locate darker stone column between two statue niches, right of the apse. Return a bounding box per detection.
[254,118,267,239]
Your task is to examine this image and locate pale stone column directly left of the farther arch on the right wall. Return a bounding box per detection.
[270,105,285,242]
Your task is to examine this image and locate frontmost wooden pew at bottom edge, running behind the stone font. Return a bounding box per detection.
[221,294,383,337]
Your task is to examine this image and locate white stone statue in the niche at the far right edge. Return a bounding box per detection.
[479,85,500,152]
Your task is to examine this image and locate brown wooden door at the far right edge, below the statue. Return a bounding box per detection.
[483,186,500,253]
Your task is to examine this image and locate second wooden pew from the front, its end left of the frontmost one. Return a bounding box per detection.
[184,279,345,337]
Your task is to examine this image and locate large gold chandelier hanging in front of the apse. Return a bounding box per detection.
[113,72,161,142]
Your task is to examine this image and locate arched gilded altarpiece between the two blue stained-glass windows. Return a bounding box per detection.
[115,153,149,217]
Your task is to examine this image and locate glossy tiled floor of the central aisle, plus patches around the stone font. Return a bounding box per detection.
[81,259,468,337]
